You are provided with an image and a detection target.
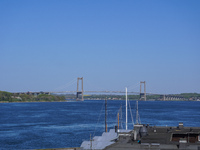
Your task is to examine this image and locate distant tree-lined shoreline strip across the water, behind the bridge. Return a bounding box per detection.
[0,91,200,103]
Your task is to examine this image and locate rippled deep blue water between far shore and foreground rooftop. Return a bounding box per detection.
[0,100,200,149]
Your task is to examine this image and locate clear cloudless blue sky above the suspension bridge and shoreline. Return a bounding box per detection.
[0,0,200,93]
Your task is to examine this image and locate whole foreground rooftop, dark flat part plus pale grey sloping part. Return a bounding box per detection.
[80,123,200,150]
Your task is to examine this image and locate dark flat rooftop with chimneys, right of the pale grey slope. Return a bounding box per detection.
[104,123,200,150]
